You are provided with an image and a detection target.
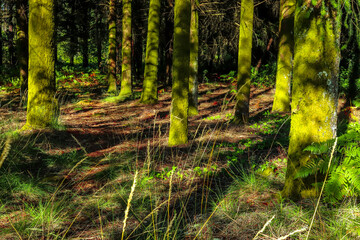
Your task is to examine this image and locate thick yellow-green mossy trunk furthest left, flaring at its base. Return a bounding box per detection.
[23,0,59,129]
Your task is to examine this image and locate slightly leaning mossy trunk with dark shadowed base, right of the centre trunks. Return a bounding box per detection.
[235,0,254,124]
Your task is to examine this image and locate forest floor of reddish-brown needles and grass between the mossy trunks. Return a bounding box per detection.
[0,75,360,239]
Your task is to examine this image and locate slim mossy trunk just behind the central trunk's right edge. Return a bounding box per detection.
[188,0,199,116]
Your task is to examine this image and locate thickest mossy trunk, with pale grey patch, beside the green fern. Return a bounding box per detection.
[282,0,340,200]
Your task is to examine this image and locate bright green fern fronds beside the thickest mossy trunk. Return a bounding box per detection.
[296,123,360,203]
